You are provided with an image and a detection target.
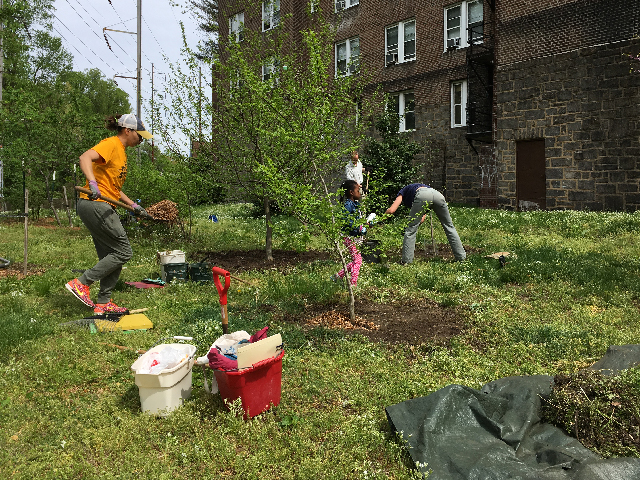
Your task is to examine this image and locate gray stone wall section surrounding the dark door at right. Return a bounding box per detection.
[495,40,640,211]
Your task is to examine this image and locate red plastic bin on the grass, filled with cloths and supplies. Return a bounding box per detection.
[214,350,284,419]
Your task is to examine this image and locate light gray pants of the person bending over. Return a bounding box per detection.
[402,187,467,263]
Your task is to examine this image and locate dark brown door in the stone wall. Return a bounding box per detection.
[516,140,547,210]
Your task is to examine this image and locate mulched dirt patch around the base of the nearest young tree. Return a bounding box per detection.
[293,298,465,345]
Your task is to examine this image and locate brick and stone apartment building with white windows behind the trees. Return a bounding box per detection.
[219,0,640,211]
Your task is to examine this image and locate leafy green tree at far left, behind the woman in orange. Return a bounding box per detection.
[0,0,130,215]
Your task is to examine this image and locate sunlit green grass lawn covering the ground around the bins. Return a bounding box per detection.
[0,205,640,480]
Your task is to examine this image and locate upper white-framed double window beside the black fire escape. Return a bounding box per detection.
[444,0,484,50]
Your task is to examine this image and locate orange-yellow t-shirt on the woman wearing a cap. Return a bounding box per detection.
[80,136,127,201]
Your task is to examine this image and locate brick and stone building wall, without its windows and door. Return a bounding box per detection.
[220,0,640,210]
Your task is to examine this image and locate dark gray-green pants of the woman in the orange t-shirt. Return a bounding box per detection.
[78,198,133,303]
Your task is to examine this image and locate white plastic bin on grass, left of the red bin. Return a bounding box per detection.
[131,343,196,417]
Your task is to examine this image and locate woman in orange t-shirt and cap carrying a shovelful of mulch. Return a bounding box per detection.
[65,113,153,314]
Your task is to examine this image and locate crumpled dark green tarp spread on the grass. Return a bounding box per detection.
[386,345,640,480]
